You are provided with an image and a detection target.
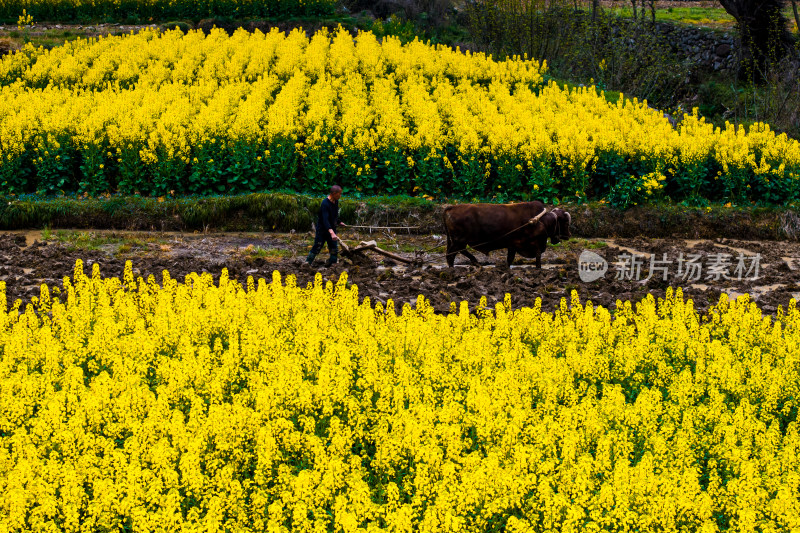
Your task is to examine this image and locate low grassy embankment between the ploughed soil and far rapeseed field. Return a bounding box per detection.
[0,193,800,239]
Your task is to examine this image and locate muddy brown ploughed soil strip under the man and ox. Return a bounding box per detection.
[0,230,800,315]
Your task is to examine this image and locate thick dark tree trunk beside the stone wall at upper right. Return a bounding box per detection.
[720,0,795,81]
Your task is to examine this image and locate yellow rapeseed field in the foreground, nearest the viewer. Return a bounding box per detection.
[0,262,800,532]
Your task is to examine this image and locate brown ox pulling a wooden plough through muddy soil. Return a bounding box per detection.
[443,201,571,268]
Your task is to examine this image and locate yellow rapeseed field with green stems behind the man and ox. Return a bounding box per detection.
[0,30,800,205]
